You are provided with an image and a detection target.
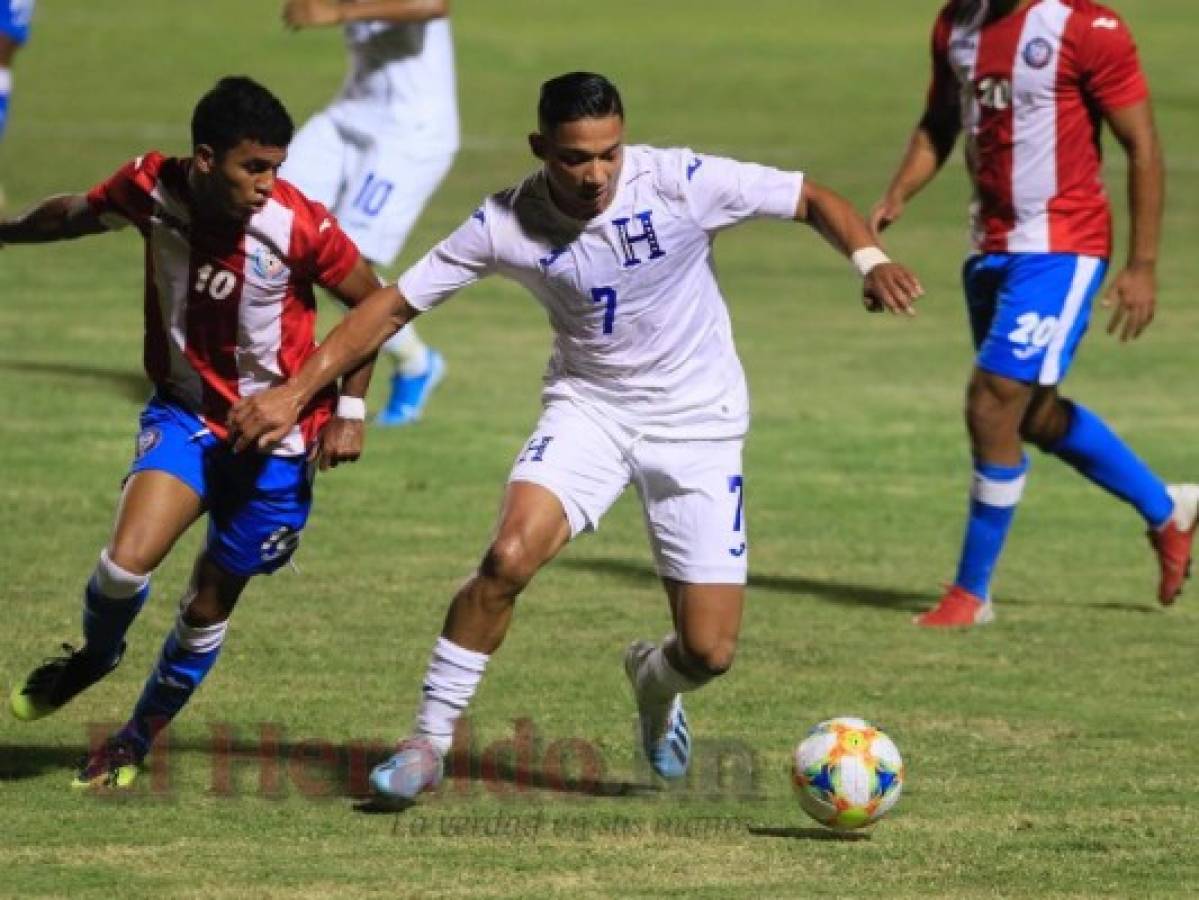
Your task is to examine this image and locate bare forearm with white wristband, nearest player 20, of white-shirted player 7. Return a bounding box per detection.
[795,179,924,315]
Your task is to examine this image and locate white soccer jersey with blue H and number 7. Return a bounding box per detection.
[398,146,803,440]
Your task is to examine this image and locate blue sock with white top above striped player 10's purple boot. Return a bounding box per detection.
[119,615,228,756]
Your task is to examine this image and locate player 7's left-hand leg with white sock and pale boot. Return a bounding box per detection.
[370,482,571,801]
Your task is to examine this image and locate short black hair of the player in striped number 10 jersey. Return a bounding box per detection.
[192,75,295,156]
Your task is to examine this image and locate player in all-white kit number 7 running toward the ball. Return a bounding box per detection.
[223,72,921,799]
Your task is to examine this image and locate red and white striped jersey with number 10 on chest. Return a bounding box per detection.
[88,152,359,455]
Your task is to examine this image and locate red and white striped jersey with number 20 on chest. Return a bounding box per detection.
[928,0,1149,258]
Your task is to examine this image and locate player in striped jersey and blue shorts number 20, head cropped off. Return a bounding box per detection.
[870,0,1199,627]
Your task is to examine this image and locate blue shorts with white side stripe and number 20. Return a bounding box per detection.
[962,253,1108,385]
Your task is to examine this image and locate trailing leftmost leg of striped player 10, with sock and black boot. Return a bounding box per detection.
[10,471,203,721]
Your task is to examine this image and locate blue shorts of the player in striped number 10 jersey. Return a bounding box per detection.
[129,395,312,576]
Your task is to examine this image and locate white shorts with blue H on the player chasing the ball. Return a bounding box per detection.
[508,401,749,585]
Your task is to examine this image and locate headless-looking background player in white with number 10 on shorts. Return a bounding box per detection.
[283,0,458,425]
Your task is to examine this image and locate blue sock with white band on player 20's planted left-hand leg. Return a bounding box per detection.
[953,457,1029,600]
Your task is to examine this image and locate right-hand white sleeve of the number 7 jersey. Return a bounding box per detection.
[682,152,803,231]
